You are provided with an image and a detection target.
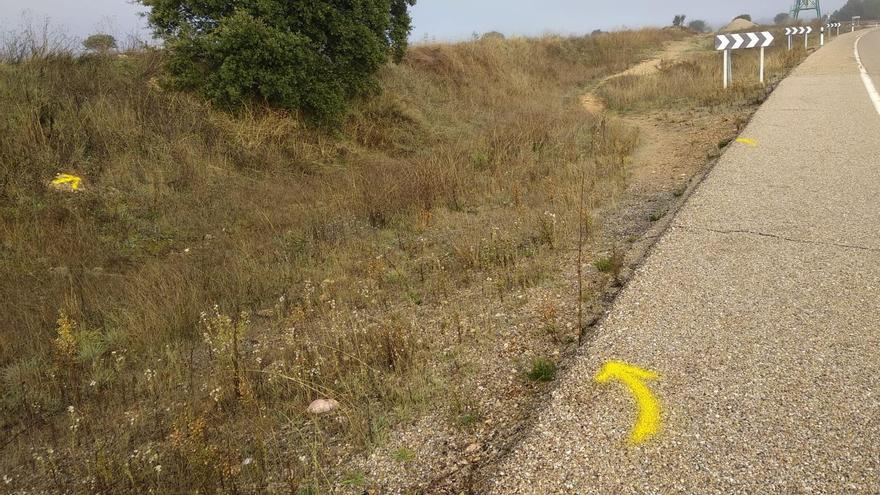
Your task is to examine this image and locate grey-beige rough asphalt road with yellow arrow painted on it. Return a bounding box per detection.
[486,30,880,494]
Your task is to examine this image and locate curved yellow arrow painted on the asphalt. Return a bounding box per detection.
[595,361,660,444]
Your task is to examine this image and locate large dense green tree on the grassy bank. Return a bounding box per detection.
[139,0,415,123]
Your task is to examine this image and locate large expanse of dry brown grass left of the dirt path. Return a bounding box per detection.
[0,30,700,493]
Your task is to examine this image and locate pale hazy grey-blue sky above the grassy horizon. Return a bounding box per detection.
[0,0,845,40]
